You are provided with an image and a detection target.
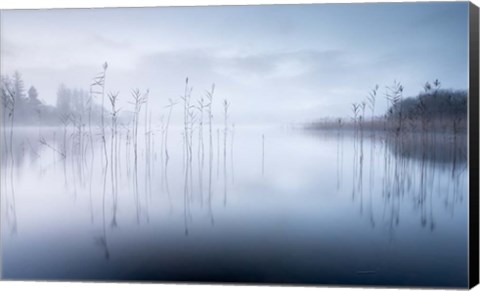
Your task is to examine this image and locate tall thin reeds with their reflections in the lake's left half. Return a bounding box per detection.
[2,62,239,244]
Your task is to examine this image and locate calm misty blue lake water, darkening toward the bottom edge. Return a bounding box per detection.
[2,128,468,287]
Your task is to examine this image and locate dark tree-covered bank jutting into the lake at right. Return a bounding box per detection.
[306,79,468,133]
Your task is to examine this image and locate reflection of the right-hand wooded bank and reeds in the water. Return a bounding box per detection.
[336,128,467,240]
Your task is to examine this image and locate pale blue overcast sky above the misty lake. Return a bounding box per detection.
[0,2,468,124]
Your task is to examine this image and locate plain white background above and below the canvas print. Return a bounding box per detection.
[0,0,480,291]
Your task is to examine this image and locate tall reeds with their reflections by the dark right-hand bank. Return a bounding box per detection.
[337,80,465,238]
